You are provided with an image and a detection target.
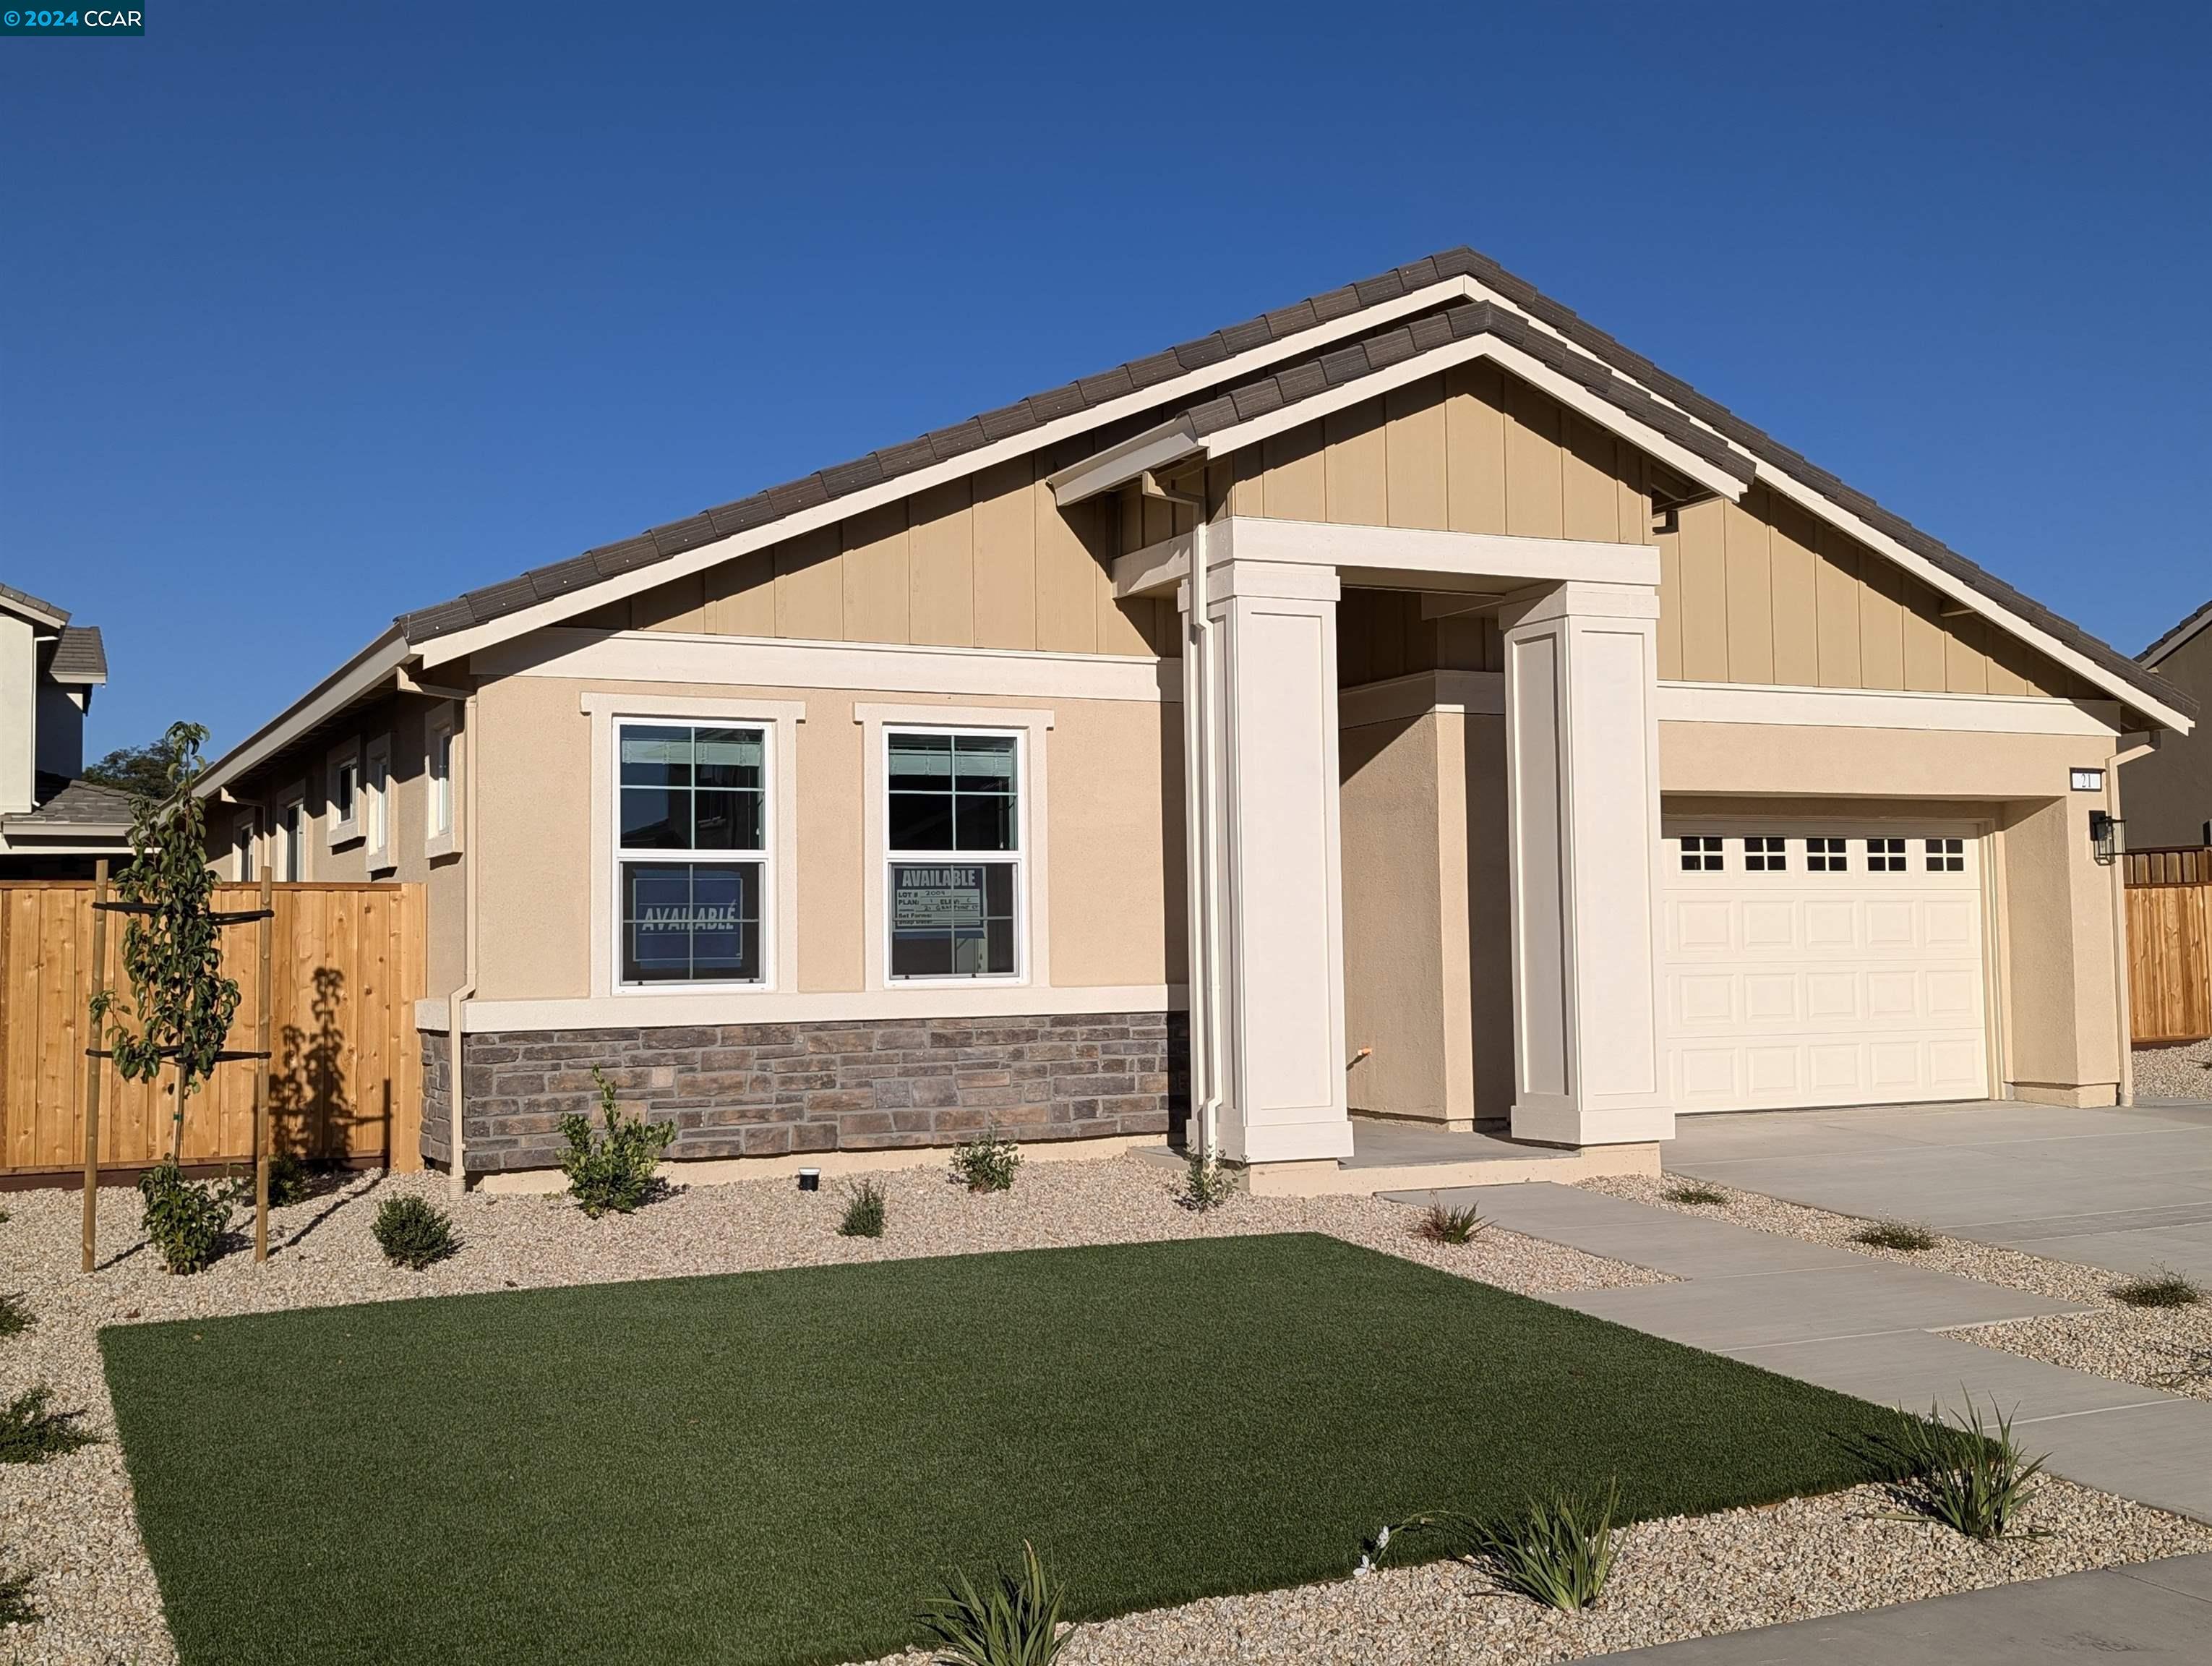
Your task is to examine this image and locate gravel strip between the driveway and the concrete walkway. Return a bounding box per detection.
[1584,1168,2212,1401]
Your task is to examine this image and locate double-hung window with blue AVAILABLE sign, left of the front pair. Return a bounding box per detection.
[615,724,770,985]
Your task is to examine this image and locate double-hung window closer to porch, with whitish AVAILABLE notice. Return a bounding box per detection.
[883,728,1024,978]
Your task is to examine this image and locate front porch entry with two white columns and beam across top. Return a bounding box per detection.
[1115,506,1672,1168]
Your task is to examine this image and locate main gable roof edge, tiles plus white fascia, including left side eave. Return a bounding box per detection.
[204,248,2197,792]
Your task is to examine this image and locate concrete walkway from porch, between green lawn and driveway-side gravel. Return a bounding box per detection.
[1396,1184,2212,1522]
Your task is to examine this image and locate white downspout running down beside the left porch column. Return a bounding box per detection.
[1137,469,1223,1175]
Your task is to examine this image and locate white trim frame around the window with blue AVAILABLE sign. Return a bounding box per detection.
[580,691,807,1002]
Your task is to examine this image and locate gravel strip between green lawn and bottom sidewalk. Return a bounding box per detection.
[849,1480,2212,1666]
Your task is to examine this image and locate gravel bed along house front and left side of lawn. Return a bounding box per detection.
[0,1157,1661,1666]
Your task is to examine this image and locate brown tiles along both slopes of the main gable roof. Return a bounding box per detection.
[398,246,2197,714]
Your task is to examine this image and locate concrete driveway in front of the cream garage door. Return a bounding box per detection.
[1663,1100,2212,1286]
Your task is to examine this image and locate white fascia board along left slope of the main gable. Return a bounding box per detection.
[420,279,1478,670]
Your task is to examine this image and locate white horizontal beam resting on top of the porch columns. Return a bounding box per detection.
[1113,516,1659,597]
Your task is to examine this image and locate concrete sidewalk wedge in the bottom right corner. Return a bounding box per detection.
[1608,1555,2212,1666]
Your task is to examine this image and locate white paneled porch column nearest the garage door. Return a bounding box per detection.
[1500,582,1674,1146]
